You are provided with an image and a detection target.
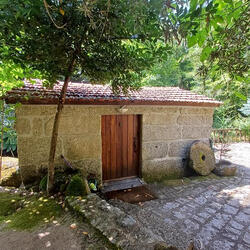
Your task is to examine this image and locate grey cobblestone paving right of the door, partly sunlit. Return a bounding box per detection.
[111,143,250,250]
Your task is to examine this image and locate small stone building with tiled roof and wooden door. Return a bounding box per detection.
[6,83,220,182]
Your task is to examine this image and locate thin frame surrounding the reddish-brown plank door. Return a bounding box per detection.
[101,114,142,183]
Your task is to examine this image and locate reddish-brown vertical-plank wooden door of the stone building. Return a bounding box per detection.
[102,115,140,180]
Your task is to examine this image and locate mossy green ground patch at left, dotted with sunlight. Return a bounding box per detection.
[0,193,63,230]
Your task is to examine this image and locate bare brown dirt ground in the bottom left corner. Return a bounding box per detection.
[0,214,111,250]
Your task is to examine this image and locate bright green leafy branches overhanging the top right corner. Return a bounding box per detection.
[179,0,250,81]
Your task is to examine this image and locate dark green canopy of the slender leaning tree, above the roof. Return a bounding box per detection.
[0,0,167,90]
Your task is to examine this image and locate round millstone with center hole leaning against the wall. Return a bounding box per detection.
[189,141,215,175]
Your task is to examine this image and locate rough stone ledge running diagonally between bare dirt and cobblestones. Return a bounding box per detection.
[67,194,190,250]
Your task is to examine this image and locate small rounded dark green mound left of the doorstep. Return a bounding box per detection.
[66,175,87,196]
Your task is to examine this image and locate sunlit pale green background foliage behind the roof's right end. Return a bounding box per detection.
[143,45,250,130]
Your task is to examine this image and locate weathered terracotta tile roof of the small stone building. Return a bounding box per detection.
[5,81,221,106]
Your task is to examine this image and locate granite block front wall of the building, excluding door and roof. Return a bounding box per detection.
[16,105,213,182]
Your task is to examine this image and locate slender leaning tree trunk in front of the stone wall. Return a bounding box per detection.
[47,58,75,194]
